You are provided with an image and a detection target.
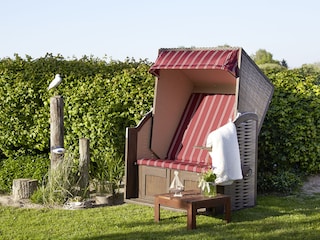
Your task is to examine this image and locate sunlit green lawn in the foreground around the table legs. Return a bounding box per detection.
[0,195,320,240]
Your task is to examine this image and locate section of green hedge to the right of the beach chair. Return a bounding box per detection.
[258,68,320,192]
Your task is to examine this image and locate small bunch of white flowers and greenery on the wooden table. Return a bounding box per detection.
[198,169,217,197]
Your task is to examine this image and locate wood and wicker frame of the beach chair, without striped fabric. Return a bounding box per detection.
[125,48,273,210]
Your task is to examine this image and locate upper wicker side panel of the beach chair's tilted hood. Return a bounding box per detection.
[238,50,274,133]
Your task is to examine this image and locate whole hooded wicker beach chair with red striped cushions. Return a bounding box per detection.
[125,48,273,209]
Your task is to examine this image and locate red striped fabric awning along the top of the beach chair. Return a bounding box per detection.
[150,49,240,77]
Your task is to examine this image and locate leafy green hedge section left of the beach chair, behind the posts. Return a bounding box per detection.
[0,54,154,191]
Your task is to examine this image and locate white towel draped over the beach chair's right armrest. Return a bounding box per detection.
[206,122,242,185]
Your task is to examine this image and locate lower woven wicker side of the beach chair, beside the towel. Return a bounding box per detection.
[224,120,257,210]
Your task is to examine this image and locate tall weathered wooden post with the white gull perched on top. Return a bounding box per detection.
[50,96,64,169]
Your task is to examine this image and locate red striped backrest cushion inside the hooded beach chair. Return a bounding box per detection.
[167,93,235,164]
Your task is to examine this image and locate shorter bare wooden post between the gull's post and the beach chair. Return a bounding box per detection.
[79,138,90,193]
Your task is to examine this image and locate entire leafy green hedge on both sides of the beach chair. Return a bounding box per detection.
[0,54,320,192]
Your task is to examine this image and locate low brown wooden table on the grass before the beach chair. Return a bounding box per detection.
[154,191,231,229]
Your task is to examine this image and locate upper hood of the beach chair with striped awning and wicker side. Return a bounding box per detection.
[150,48,273,133]
